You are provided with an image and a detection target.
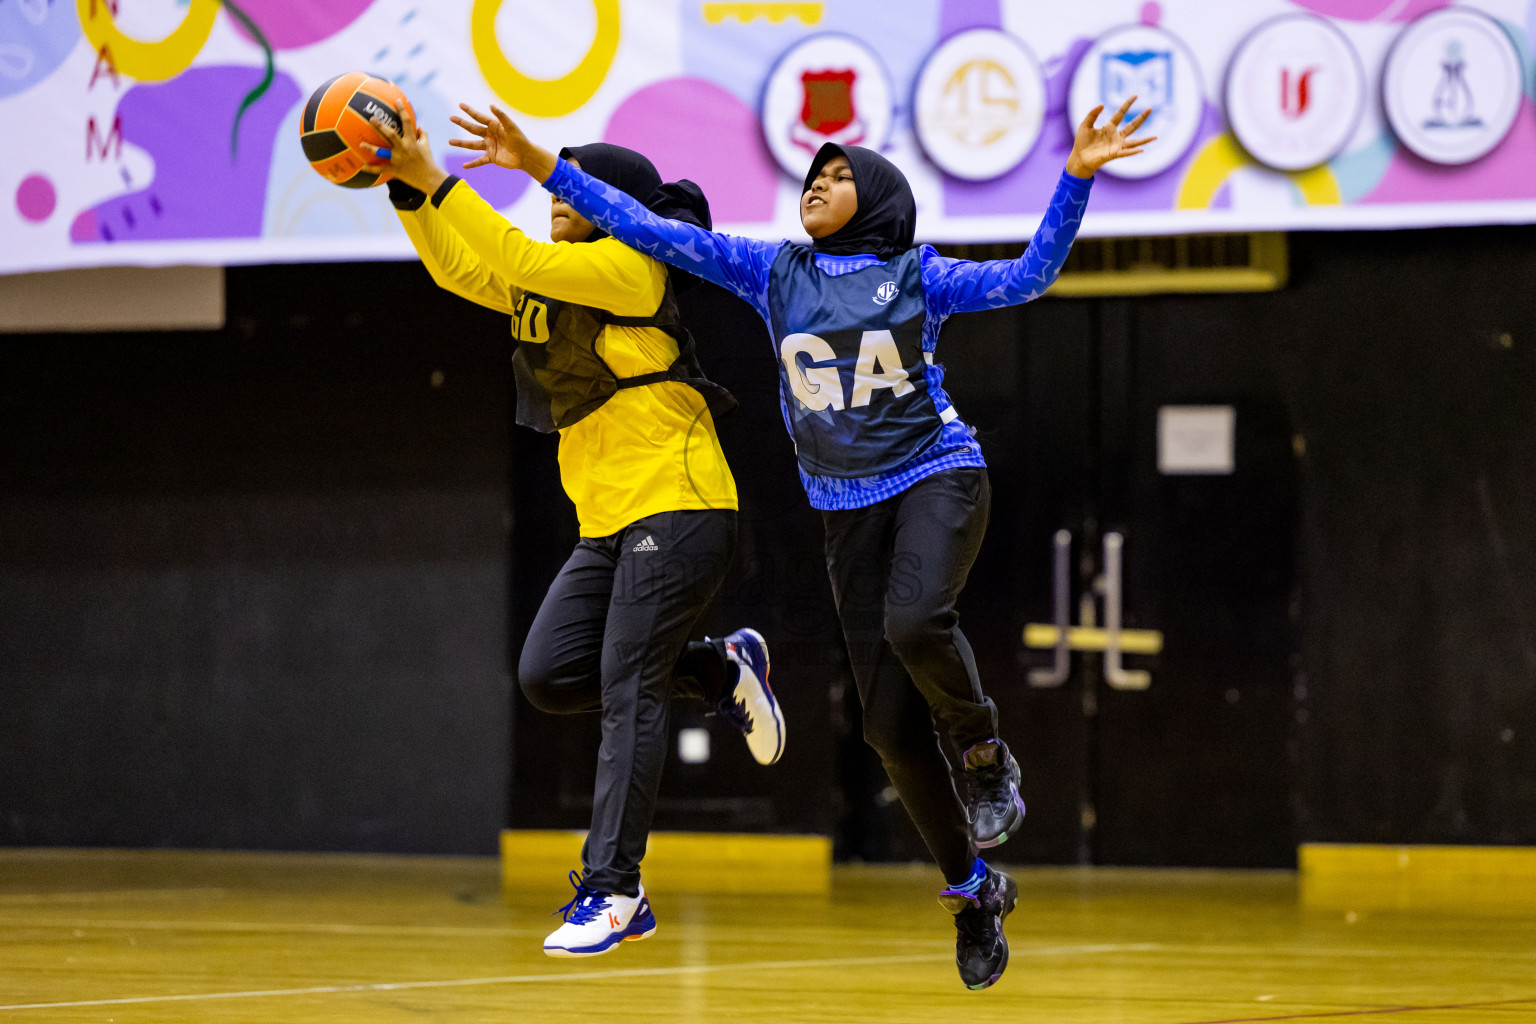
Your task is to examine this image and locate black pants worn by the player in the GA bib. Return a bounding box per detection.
[822,468,997,883]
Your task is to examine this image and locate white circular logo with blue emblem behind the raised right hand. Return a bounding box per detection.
[1066,25,1206,178]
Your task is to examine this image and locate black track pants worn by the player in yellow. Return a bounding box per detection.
[518,510,736,897]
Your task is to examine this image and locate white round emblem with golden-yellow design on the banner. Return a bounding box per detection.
[912,29,1046,181]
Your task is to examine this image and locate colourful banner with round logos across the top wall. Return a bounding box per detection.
[9,0,1536,273]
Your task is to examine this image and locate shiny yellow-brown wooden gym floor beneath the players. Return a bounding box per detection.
[0,851,1536,1024]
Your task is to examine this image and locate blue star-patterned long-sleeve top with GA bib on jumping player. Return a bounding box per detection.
[544,160,1092,510]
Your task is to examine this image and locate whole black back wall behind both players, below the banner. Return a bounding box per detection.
[0,229,1536,863]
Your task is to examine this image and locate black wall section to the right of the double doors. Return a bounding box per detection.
[1228,227,1536,844]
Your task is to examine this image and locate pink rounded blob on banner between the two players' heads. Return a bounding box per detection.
[602,78,779,224]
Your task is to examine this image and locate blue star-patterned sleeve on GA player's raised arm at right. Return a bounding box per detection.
[923,170,1094,319]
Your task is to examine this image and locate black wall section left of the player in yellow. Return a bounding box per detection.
[0,264,508,852]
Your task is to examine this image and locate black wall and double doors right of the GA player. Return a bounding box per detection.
[942,227,1536,863]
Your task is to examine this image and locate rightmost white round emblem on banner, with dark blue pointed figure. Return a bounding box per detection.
[1381,8,1524,164]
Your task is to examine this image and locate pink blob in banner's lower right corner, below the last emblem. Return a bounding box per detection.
[1361,100,1536,203]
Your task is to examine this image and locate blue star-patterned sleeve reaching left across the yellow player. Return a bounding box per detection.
[544,160,783,319]
